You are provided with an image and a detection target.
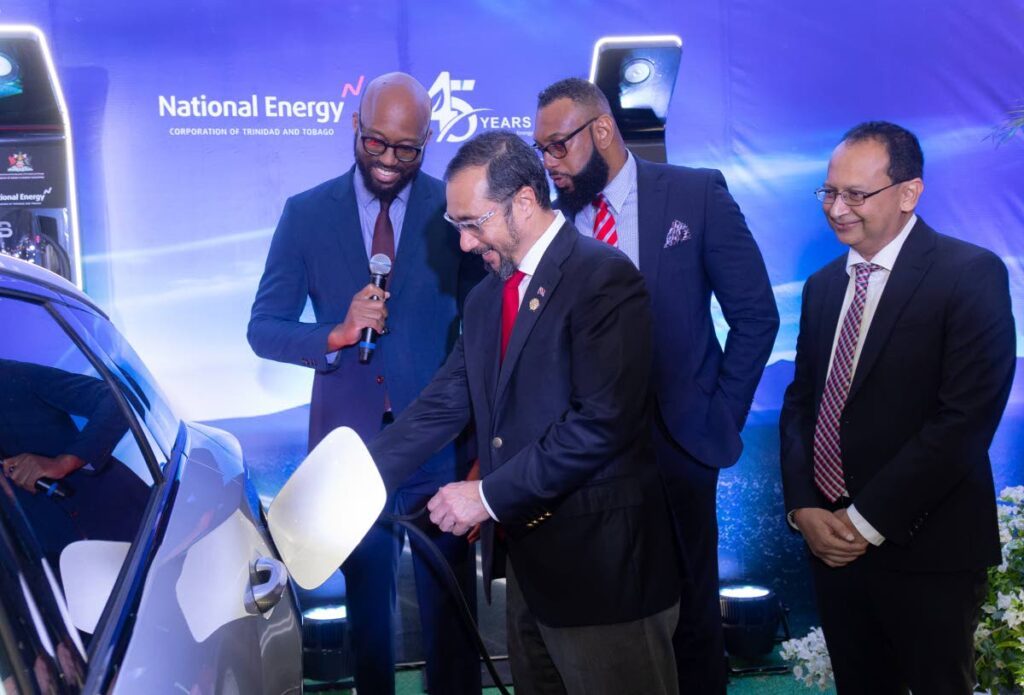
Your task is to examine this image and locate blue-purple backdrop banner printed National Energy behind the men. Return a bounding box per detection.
[0,0,1024,630]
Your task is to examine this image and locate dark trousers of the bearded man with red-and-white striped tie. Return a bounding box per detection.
[653,422,727,695]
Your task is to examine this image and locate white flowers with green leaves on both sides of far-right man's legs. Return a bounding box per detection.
[780,485,1024,693]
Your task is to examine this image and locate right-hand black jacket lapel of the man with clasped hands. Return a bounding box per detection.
[847,218,935,401]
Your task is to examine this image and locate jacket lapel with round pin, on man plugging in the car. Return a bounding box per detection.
[495,222,579,412]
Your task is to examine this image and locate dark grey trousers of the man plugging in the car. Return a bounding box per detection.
[506,561,679,695]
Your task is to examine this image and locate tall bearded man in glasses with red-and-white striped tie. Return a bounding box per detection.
[534,78,778,695]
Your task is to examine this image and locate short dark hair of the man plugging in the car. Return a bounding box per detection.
[444,130,551,210]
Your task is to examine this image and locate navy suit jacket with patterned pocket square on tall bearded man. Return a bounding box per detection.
[637,158,778,468]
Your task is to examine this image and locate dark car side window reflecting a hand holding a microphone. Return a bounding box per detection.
[0,295,154,642]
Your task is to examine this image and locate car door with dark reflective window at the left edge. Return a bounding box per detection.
[0,286,160,693]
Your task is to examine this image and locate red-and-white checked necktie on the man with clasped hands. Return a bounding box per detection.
[814,263,882,502]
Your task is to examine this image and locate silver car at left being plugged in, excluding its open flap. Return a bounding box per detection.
[0,276,301,693]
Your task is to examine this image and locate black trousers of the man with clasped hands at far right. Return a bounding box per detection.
[811,560,986,695]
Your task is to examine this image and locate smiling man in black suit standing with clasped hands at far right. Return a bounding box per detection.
[779,122,1016,695]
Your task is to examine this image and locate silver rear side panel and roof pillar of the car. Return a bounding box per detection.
[59,306,302,694]
